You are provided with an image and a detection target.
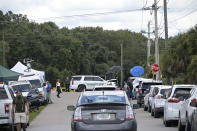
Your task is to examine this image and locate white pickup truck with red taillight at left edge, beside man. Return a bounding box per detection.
[0,82,29,130]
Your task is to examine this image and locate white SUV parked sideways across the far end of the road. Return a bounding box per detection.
[70,75,108,92]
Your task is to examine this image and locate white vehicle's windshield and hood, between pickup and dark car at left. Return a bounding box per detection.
[8,80,32,97]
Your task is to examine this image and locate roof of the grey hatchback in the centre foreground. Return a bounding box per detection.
[82,90,125,96]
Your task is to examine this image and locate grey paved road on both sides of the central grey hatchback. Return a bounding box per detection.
[27,93,177,131]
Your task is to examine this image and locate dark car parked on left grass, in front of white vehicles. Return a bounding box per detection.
[27,89,43,110]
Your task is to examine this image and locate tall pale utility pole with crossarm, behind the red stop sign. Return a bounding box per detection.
[153,0,160,80]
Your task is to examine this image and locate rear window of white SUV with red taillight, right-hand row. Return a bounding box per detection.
[172,88,191,101]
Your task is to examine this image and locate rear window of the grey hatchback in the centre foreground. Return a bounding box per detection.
[78,95,126,105]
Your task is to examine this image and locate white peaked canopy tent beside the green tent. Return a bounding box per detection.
[10,61,45,80]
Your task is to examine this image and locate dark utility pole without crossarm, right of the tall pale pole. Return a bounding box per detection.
[163,0,168,49]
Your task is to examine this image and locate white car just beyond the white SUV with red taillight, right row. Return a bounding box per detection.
[150,85,172,118]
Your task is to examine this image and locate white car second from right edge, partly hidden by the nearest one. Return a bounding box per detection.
[178,87,197,131]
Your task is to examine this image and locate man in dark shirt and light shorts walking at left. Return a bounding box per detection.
[12,91,29,131]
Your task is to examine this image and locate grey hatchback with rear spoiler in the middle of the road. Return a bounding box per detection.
[67,91,137,131]
